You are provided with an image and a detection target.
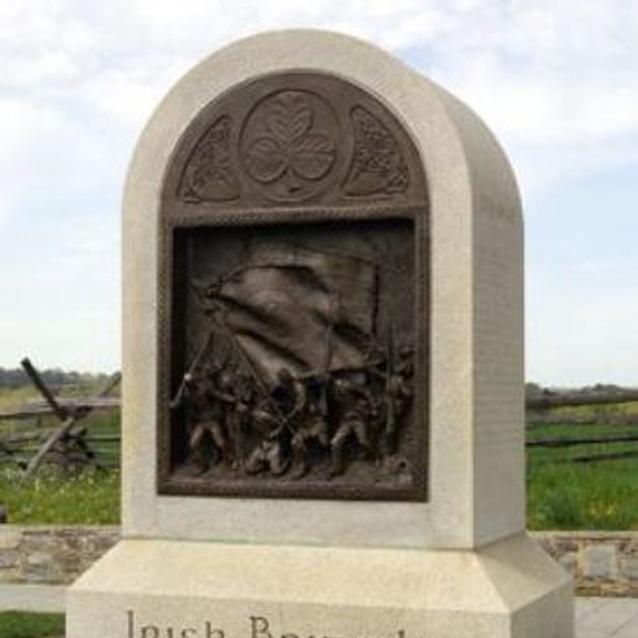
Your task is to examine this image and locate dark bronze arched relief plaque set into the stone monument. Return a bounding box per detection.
[157,72,429,501]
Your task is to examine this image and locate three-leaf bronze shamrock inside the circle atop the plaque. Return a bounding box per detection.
[245,91,335,184]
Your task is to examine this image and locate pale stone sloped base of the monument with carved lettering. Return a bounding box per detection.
[67,534,573,638]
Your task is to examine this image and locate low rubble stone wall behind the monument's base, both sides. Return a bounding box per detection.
[0,525,638,597]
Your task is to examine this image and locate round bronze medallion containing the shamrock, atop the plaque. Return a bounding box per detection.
[242,90,337,201]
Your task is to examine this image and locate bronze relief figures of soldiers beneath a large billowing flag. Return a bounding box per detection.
[171,240,413,480]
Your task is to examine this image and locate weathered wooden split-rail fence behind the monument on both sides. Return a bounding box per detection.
[0,358,638,476]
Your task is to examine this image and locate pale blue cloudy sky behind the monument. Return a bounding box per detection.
[0,0,638,386]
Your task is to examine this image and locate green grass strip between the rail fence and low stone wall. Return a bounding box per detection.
[0,446,638,532]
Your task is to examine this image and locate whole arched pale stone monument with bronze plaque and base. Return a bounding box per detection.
[67,31,573,638]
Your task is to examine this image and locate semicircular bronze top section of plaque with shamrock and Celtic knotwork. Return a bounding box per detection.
[163,72,427,215]
